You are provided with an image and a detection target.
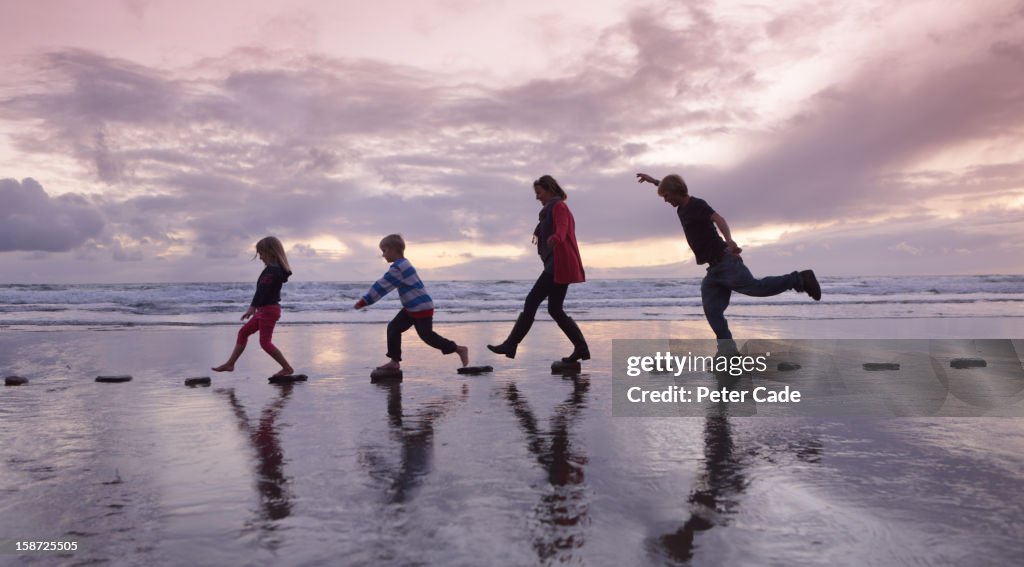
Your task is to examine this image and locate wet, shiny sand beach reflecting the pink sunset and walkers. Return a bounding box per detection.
[0,317,1024,565]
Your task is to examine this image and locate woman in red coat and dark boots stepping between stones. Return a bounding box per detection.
[487,175,590,362]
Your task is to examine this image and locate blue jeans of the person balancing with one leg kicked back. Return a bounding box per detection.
[700,254,803,339]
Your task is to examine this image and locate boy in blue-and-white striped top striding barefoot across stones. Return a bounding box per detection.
[354,234,469,370]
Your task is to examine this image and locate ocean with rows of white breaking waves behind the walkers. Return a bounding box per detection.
[0,275,1024,329]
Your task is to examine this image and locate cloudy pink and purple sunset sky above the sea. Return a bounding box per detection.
[0,0,1024,284]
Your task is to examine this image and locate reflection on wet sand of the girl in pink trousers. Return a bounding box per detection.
[217,384,294,521]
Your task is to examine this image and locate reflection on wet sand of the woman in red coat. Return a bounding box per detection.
[505,375,590,563]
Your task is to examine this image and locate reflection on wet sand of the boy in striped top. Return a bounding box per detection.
[359,384,469,504]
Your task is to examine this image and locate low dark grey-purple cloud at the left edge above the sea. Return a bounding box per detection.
[0,178,103,252]
